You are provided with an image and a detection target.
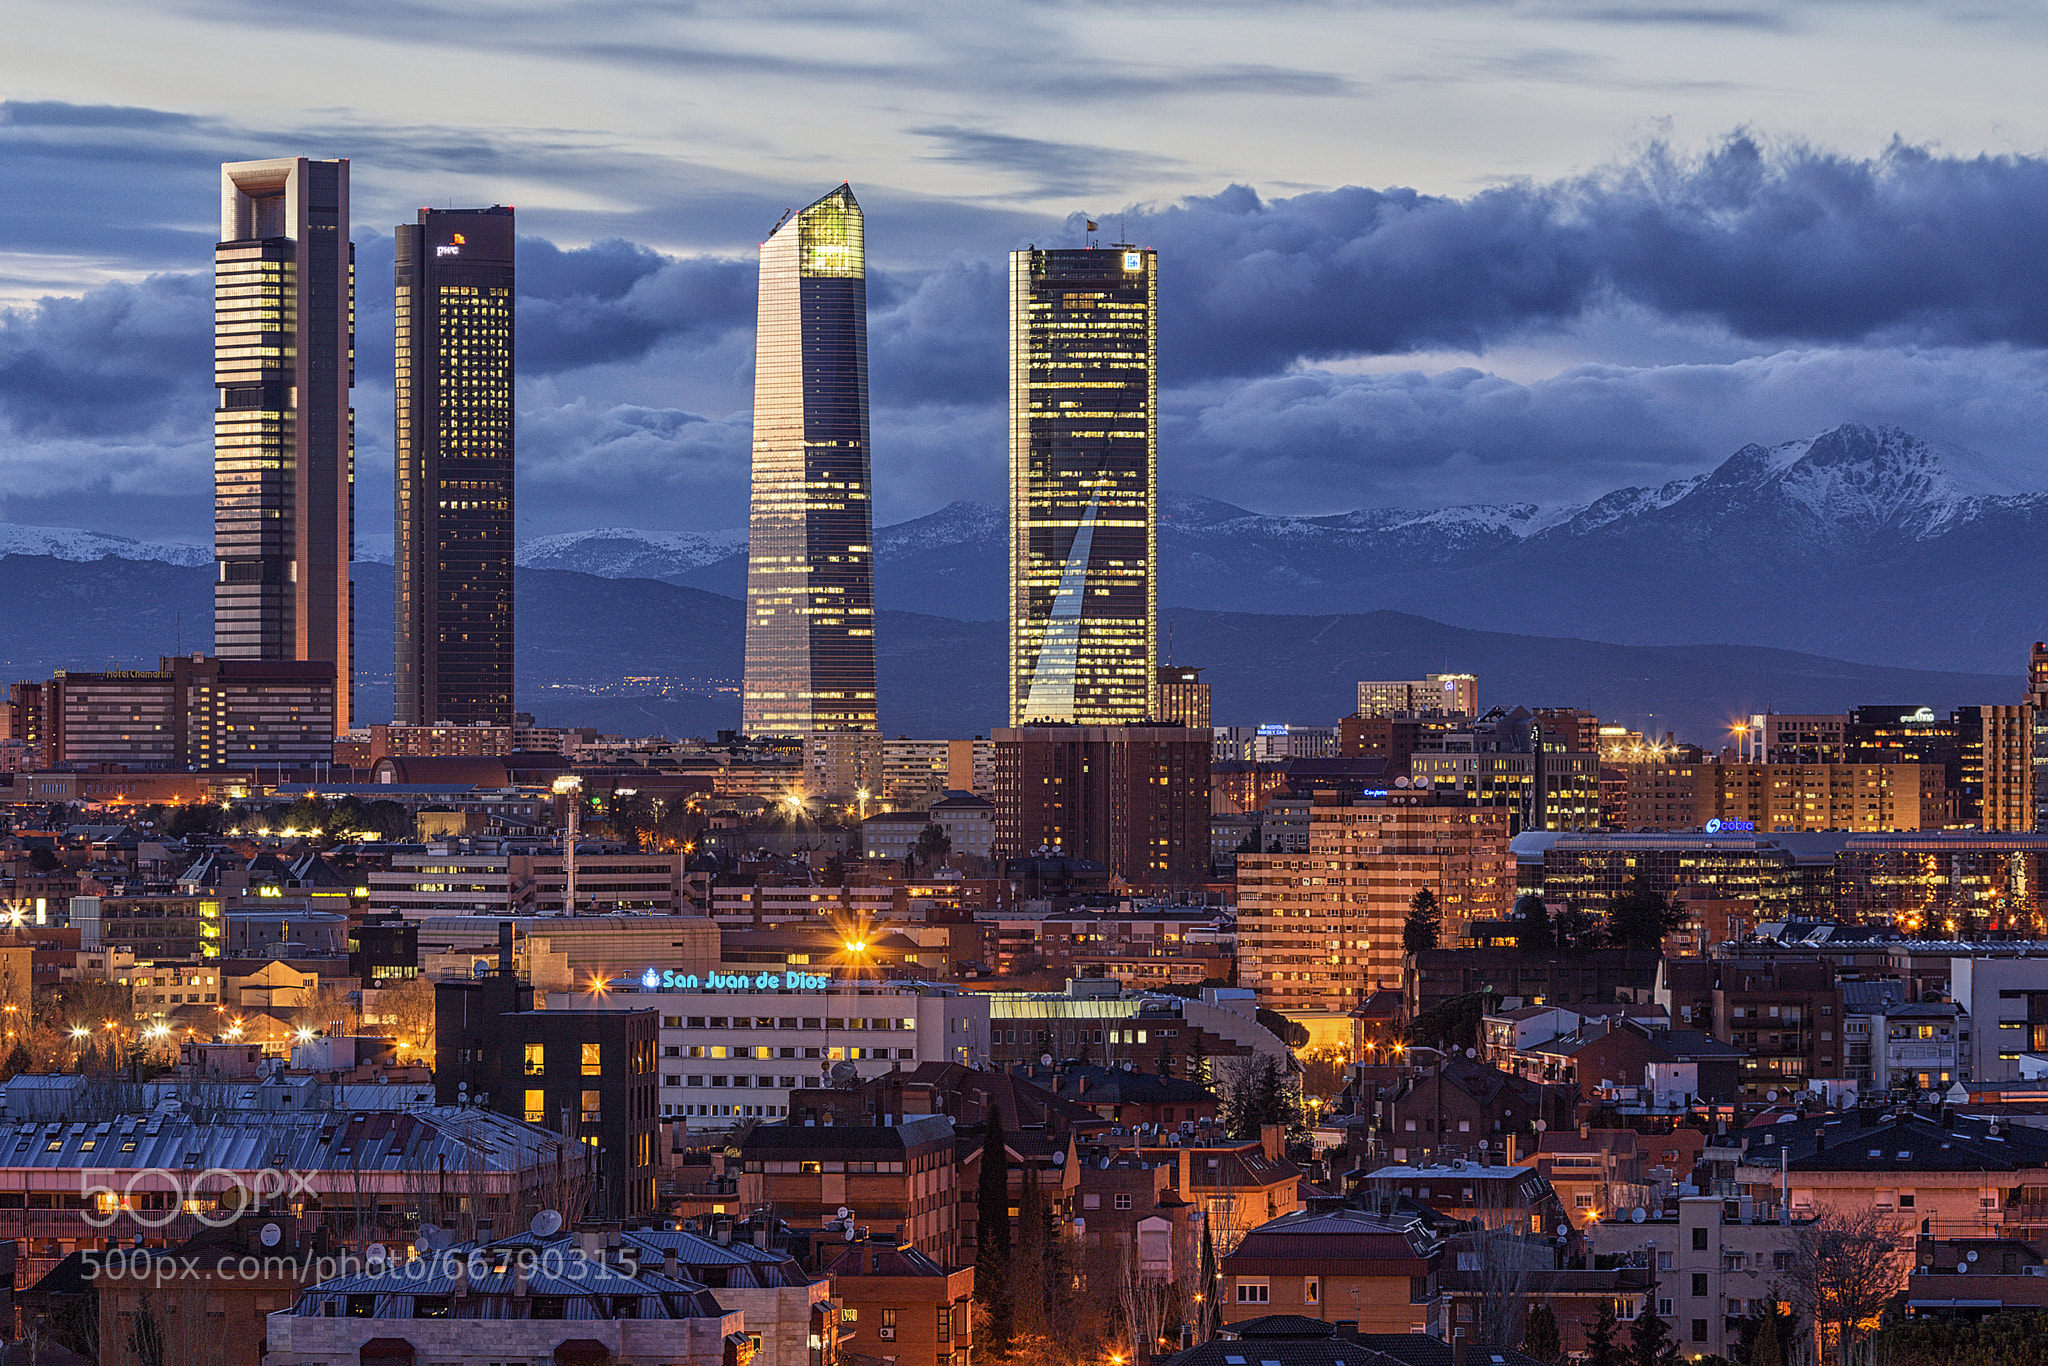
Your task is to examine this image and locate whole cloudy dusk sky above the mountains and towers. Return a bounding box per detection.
[0,0,2048,541]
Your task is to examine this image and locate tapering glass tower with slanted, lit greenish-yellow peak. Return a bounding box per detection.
[741,184,881,797]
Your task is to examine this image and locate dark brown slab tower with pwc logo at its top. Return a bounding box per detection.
[391,207,514,725]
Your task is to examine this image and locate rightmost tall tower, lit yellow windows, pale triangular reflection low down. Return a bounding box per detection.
[1010,246,1159,725]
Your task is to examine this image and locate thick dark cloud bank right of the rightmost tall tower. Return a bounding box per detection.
[1128,135,2048,379]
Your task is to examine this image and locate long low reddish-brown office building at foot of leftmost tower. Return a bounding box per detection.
[41,655,340,768]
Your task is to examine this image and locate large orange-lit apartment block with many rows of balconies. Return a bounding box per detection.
[1237,793,1513,1012]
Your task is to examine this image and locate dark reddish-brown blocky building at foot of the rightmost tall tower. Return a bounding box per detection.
[995,725,1210,887]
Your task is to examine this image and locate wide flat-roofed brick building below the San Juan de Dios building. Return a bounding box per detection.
[739,1114,973,1261]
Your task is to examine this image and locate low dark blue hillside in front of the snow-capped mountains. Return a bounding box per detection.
[0,555,2021,741]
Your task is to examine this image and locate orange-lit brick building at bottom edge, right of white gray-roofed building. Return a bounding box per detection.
[823,1236,975,1366]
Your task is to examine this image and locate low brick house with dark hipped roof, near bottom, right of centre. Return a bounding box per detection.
[1217,1206,1444,1327]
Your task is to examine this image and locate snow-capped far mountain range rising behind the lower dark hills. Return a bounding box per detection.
[368,424,2048,672]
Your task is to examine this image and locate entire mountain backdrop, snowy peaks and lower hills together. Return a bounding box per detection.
[0,426,2048,739]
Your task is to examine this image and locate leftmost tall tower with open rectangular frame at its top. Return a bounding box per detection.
[213,156,356,731]
